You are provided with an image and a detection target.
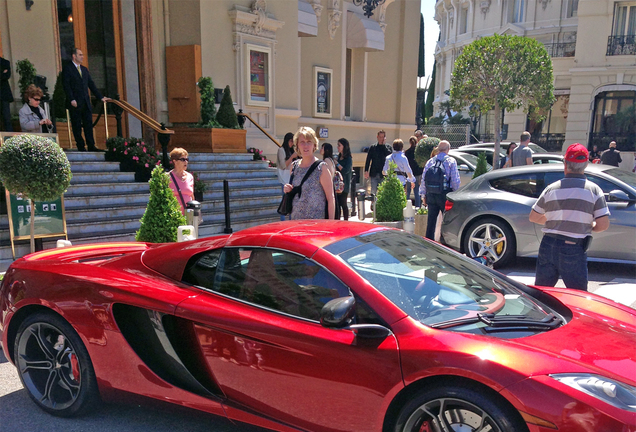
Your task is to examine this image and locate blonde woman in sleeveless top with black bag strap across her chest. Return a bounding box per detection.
[284,126,335,220]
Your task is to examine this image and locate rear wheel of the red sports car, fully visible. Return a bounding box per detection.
[14,312,98,417]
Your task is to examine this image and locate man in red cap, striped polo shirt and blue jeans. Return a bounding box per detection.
[530,143,609,291]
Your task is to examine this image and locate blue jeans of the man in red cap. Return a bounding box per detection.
[534,235,587,291]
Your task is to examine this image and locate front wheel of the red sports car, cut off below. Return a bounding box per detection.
[395,386,528,432]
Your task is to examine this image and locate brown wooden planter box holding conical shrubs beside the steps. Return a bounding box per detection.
[170,127,247,153]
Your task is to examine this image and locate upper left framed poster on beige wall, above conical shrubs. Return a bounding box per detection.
[245,44,272,107]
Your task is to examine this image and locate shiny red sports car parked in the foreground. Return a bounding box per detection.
[0,221,636,432]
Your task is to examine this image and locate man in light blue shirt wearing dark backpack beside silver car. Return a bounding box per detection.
[420,141,460,240]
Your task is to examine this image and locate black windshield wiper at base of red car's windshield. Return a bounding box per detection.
[430,313,563,332]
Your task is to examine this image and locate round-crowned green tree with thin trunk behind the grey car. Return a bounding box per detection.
[451,35,555,168]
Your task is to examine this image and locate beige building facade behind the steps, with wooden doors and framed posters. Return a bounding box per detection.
[0,0,420,155]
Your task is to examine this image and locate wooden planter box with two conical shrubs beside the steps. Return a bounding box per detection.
[170,77,247,153]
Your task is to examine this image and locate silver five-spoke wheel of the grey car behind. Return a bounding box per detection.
[464,218,517,267]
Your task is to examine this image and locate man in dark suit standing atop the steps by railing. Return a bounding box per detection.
[62,48,108,151]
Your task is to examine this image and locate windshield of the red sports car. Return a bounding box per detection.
[329,230,561,338]
